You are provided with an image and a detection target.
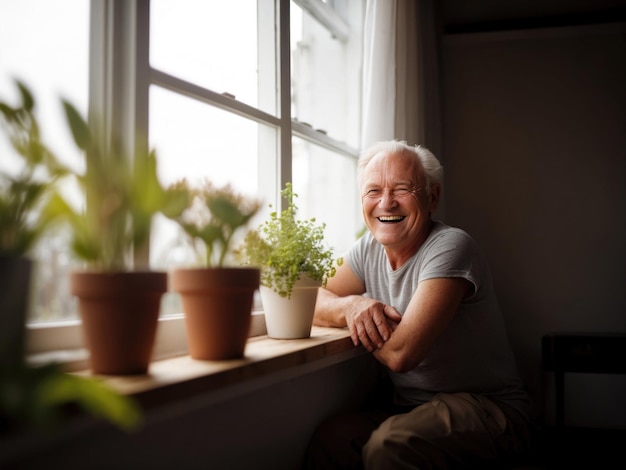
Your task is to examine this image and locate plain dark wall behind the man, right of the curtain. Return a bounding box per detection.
[441,24,626,429]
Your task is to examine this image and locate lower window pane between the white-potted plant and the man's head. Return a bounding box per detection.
[292,137,363,256]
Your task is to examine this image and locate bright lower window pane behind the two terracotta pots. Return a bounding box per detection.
[150,86,275,276]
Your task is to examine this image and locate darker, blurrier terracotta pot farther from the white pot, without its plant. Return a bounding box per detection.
[70,271,167,375]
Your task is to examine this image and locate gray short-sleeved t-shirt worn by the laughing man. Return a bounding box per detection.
[345,221,529,413]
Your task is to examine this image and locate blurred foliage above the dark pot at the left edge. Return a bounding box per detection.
[0,81,69,256]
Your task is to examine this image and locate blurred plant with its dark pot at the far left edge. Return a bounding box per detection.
[0,81,140,434]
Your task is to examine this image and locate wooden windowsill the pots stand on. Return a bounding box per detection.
[81,326,366,408]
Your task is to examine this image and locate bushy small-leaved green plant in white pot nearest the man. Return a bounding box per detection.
[238,183,342,339]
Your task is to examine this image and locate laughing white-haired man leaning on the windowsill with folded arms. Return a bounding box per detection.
[307,141,530,470]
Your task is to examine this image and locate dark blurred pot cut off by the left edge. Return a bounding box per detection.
[0,256,32,370]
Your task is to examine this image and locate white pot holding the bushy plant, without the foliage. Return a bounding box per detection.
[260,276,322,339]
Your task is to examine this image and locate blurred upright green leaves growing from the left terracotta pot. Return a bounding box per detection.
[45,101,189,271]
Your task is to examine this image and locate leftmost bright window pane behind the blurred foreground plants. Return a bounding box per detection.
[0,0,89,321]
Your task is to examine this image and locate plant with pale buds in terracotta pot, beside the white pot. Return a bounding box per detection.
[171,181,261,360]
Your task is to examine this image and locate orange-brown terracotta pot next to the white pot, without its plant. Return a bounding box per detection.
[171,267,260,360]
